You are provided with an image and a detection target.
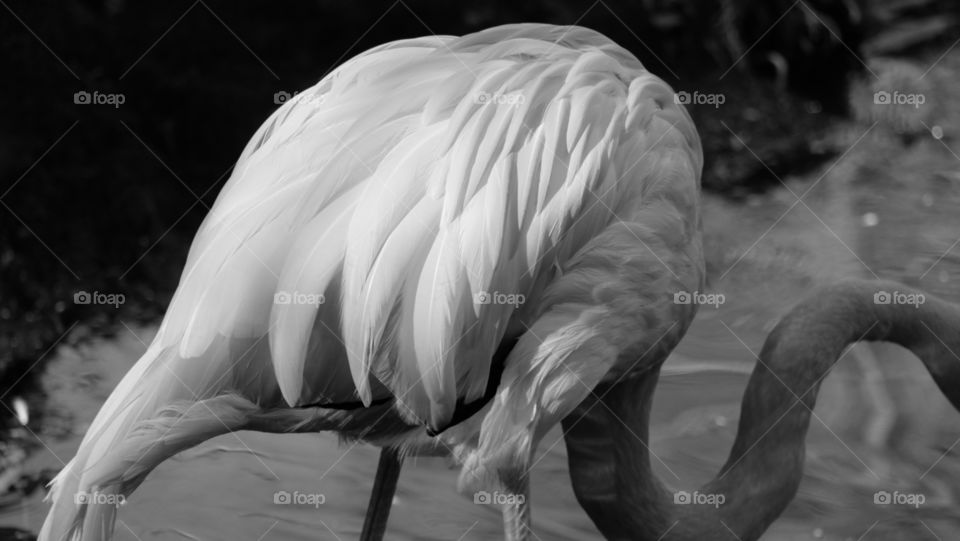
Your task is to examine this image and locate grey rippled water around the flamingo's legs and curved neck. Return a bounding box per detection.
[0,127,960,541]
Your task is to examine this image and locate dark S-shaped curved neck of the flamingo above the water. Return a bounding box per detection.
[568,281,960,541]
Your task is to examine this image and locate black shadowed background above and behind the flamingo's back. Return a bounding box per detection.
[0,0,960,480]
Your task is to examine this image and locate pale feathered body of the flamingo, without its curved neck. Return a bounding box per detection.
[40,24,703,541]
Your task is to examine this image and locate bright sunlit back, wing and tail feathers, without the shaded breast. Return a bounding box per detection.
[41,25,702,539]
